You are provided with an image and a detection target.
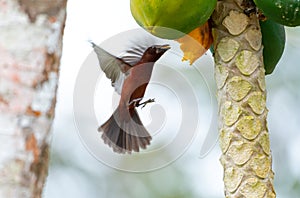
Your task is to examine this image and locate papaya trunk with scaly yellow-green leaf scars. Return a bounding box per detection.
[212,0,276,198]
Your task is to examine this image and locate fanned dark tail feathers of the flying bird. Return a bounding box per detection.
[98,107,152,153]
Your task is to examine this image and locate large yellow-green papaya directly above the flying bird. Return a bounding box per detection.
[130,0,217,39]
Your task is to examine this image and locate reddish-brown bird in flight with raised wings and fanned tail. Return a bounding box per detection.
[91,42,170,153]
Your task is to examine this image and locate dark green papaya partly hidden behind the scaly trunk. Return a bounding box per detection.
[260,20,285,74]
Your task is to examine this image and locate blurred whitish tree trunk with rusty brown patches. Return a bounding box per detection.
[0,0,66,198]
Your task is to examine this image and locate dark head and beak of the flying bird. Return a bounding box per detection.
[141,44,171,62]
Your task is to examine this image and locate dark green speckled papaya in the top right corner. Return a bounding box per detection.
[254,0,300,27]
